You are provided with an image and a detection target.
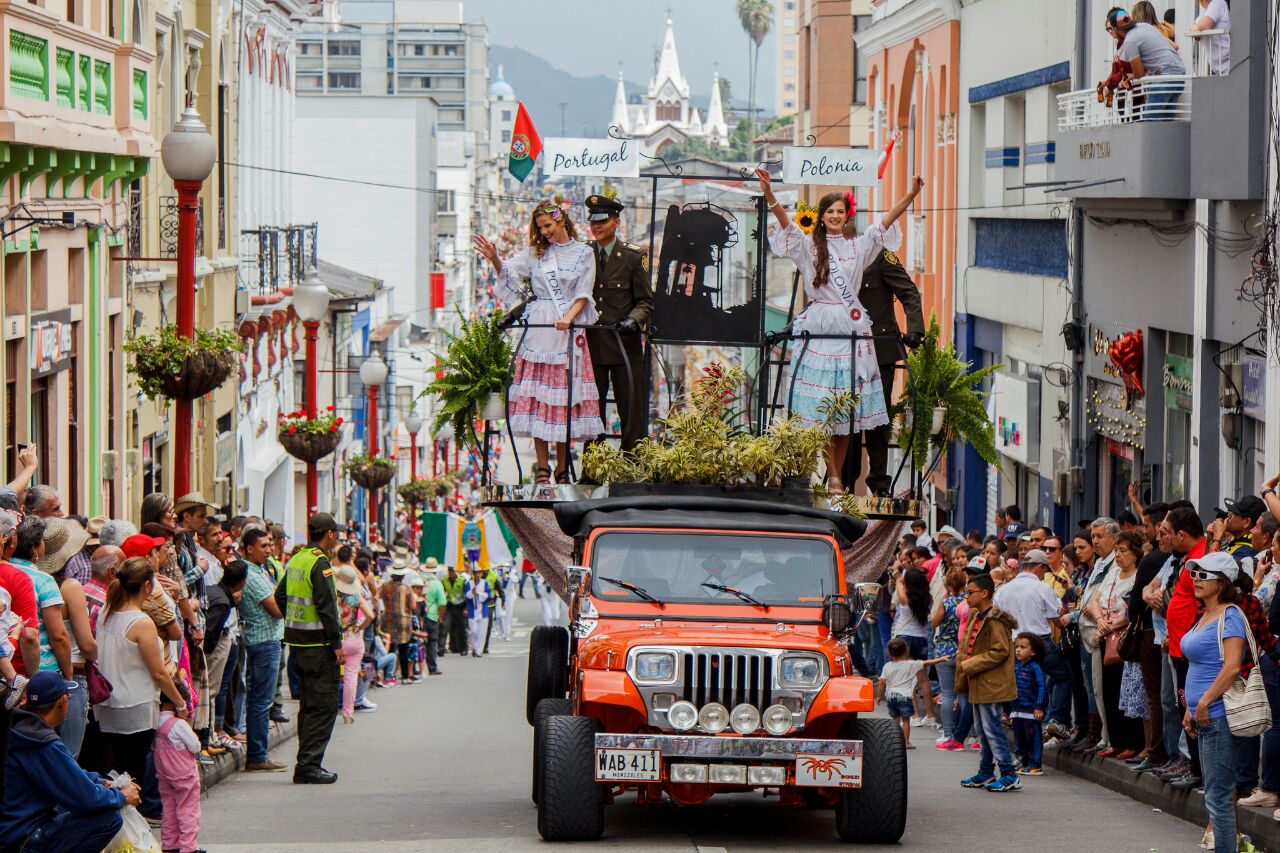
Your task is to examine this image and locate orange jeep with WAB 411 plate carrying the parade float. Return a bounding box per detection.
[527,497,906,844]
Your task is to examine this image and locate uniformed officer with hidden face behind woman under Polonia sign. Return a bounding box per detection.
[844,240,924,497]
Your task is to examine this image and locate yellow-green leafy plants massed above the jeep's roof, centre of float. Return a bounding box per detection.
[582,364,856,487]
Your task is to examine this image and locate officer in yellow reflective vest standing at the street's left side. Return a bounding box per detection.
[275,512,344,785]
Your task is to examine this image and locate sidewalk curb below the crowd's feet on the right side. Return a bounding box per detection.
[1044,748,1280,853]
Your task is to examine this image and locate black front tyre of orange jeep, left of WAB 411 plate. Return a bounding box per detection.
[534,717,604,841]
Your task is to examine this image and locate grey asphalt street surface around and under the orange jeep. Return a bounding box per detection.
[200,596,1202,853]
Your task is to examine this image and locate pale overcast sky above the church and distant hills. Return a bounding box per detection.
[463,0,778,98]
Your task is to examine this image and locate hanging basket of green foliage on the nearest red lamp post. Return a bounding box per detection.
[124,325,244,400]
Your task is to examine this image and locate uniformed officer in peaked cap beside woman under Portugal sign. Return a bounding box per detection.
[586,193,653,451]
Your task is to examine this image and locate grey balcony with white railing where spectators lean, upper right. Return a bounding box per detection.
[1057,0,1268,200]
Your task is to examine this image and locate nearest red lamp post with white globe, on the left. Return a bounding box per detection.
[160,99,218,494]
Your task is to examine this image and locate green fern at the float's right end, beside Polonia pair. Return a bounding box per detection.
[895,315,1001,470]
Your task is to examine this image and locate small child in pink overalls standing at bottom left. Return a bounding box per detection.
[152,681,204,853]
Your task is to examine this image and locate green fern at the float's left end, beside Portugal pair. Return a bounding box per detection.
[422,310,513,446]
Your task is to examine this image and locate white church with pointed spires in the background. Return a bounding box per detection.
[609,18,731,155]
